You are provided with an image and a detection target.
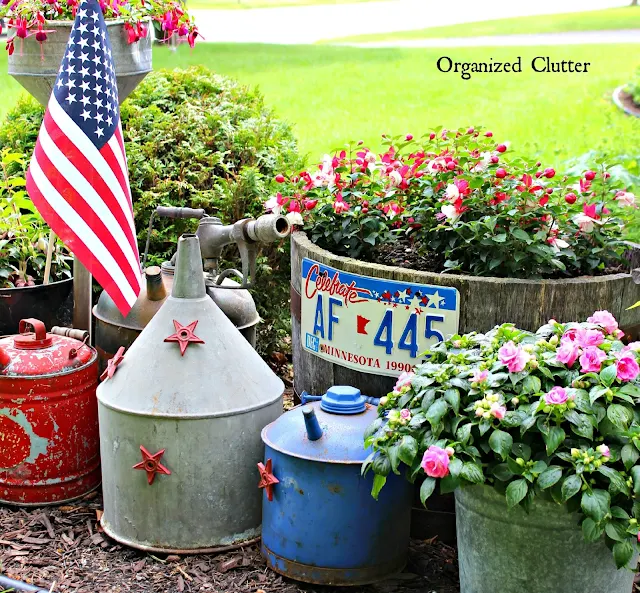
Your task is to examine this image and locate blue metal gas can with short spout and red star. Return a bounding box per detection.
[259,386,413,585]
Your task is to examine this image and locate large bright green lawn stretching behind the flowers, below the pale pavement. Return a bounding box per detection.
[0,43,640,165]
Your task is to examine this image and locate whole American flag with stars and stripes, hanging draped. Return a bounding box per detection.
[27,0,141,315]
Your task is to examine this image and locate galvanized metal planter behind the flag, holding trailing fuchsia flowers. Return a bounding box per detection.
[8,20,153,105]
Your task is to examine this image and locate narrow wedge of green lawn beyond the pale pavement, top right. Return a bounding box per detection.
[323,6,640,43]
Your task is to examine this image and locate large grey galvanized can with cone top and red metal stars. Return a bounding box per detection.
[98,235,284,553]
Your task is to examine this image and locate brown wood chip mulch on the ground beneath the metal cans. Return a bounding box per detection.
[0,492,459,593]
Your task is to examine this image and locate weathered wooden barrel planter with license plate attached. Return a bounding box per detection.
[291,232,640,541]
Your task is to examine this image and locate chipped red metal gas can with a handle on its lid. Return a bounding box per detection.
[0,319,100,505]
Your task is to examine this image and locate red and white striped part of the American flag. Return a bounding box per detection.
[27,93,141,315]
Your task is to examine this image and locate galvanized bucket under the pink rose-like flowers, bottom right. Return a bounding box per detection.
[456,486,637,593]
